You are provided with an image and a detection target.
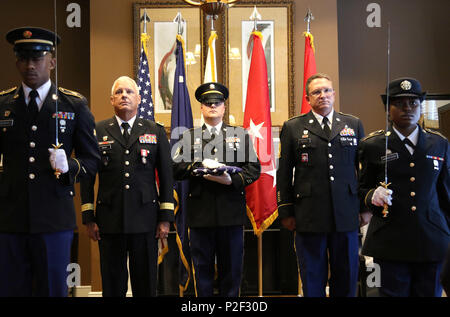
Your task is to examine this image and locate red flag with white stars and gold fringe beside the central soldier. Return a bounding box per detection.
[244,31,278,235]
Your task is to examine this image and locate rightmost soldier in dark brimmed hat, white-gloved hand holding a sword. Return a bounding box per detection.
[359,77,450,296]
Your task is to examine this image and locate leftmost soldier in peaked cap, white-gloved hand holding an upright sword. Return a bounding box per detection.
[0,27,100,296]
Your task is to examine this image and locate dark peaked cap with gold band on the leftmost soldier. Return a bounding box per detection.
[6,26,61,57]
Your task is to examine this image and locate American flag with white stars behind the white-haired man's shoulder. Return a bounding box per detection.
[137,45,155,121]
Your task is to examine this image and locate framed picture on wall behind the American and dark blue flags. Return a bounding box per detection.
[133,0,203,128]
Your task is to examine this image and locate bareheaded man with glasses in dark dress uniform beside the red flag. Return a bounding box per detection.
[277,73,364,297]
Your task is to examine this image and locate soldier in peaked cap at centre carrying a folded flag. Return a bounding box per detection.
[173,83,261,297]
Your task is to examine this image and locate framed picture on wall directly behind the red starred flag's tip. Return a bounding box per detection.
[225,0,295,127]
